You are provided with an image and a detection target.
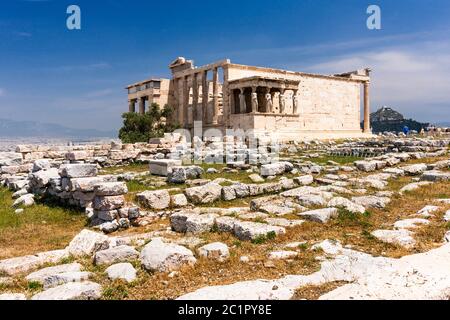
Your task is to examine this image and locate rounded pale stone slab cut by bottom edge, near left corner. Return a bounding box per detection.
[31,281,102,300]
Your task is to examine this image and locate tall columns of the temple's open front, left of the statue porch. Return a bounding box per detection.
[174,67,219,125]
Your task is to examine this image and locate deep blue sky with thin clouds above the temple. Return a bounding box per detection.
[0,0,450,130]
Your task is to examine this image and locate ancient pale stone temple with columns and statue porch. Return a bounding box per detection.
[127,57,371,141]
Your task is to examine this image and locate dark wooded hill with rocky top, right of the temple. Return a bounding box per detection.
[361,106,430,133]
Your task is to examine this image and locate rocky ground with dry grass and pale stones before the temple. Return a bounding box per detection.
[0,137,450,300]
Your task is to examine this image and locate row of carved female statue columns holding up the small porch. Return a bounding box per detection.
[235,86,299,114]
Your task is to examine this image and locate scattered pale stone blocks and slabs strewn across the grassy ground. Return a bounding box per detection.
[0,137,450,300]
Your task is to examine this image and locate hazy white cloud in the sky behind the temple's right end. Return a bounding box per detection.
[303,42,450,121]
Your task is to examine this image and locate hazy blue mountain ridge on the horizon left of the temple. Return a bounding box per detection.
[0,119,117,138]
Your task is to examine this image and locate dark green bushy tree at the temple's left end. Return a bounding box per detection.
[119,103,178,143]
